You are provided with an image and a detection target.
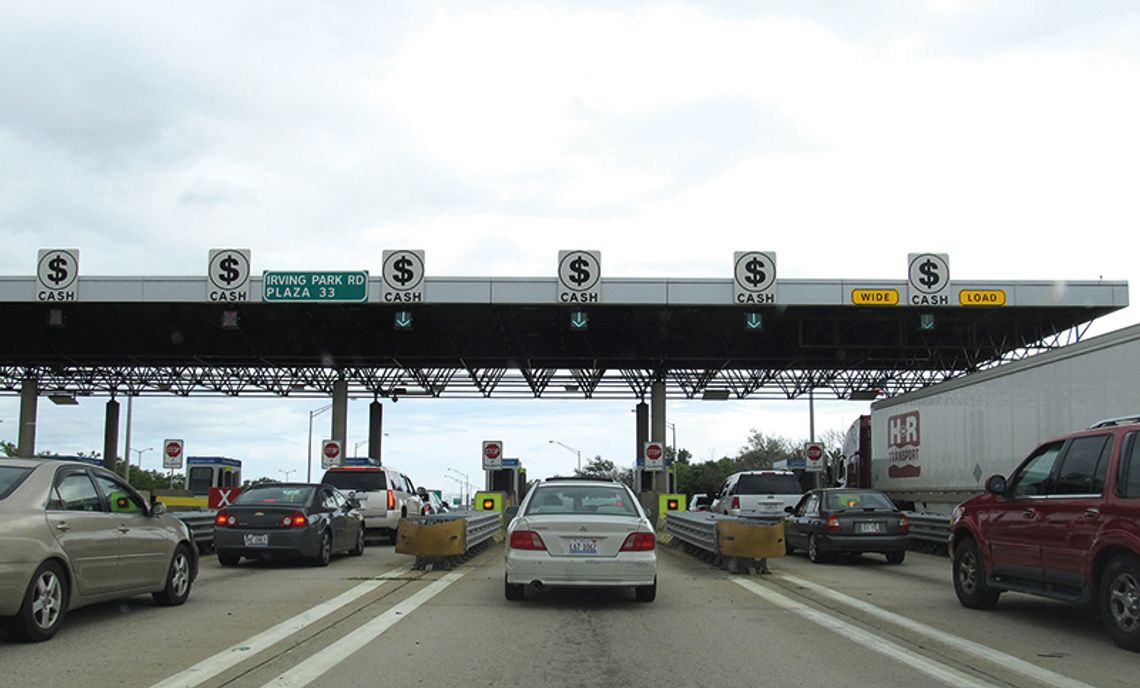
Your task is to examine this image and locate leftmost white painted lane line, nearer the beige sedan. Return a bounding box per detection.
[150,564,412,688]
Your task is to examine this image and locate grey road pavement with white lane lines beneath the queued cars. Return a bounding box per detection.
[0,544,1140,688]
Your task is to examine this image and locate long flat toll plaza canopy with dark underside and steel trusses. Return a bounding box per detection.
[0,273,1127,399]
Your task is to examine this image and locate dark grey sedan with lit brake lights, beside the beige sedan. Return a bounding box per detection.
[214,483,365,566]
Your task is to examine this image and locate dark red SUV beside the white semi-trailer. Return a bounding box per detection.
[950,416,1140,652]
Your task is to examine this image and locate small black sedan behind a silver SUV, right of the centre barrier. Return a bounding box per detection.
[784,488,910,564]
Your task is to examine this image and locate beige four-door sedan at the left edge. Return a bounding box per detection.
[0,458,197,641]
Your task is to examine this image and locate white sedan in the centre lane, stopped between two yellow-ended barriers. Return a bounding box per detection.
[505,480,657,601]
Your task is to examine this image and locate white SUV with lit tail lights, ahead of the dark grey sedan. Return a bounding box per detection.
[320,466,423,544]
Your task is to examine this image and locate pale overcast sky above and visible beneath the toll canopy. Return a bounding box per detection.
[0,0,1140,490]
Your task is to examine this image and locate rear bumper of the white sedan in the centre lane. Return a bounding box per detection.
[506,549,657,588]
